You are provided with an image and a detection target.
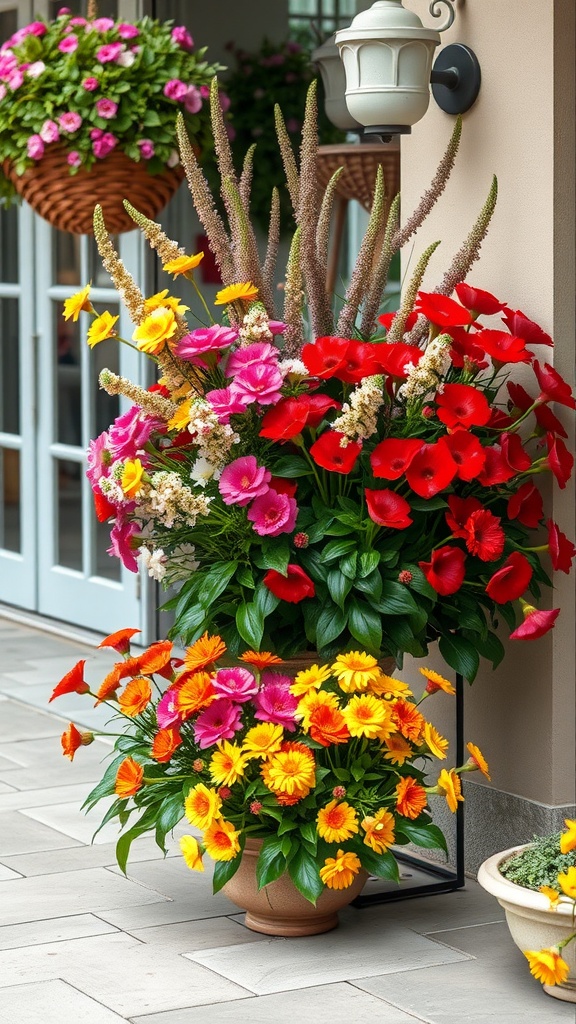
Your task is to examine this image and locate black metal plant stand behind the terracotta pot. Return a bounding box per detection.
[353,674,464,908]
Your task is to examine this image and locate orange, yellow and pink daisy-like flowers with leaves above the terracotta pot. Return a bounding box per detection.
[50,630,489,903]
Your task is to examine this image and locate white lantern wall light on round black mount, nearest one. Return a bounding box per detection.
[335,0,481,141]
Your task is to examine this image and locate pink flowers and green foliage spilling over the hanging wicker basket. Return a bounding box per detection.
[0,7,219,201]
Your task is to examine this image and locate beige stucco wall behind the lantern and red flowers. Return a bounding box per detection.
[402,0,576,805]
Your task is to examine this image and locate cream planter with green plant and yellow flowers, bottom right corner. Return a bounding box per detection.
[478,818,576,1002]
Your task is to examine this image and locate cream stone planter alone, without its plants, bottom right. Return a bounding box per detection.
[478,846,576,1002]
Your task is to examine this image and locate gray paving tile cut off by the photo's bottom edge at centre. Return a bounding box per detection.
[133,983,424,1024]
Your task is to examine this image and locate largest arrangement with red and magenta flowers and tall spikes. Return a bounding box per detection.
[65,83,576,681]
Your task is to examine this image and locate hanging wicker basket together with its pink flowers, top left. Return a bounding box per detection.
[0,5,219,234]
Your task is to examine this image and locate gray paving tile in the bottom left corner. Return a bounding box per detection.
[0,978,126,1024]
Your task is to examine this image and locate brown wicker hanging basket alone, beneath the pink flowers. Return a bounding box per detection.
[3,145,184,234]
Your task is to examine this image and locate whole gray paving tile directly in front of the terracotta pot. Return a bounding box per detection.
[184,911,467,994]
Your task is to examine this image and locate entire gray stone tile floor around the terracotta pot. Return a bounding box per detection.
[0,612,576,1024]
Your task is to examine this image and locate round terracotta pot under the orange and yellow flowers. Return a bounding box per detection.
[222,839,368,938]
